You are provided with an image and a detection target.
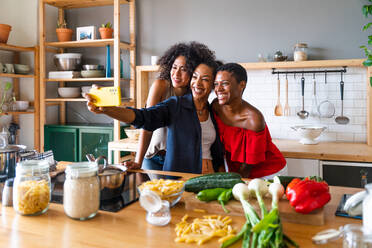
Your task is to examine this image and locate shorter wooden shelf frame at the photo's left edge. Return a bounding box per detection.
[0,43,40,151]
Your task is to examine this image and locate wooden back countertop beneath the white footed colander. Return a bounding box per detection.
[273,139,372,162]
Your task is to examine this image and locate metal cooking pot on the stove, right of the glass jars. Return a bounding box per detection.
[86,154,127,200]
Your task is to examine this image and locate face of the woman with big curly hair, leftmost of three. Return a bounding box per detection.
[170,56,190,88]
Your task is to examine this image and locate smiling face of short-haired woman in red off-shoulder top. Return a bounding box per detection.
[214,71,245,105]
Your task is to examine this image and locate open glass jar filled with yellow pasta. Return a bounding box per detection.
[13,160,51,215]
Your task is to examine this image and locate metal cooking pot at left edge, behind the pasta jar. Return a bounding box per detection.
[0,145,26,178]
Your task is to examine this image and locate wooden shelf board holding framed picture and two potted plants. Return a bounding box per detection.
[45,39,134,50]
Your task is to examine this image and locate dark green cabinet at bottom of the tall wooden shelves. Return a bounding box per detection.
[44,124,127,162]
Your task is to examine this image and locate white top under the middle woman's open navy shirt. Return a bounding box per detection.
[200,114,216,160]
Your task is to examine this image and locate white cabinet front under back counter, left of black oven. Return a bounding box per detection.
[285,158,319,177]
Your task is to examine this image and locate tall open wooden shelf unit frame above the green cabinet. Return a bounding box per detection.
[39,0,136,165]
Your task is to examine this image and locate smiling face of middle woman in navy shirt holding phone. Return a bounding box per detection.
[190,64,214,100]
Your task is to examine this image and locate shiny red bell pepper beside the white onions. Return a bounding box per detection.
[286,178,331,214]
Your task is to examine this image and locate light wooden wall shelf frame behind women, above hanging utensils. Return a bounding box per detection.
[136,59,372,146]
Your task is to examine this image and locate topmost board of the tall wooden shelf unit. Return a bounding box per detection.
[43,0,129,9]
